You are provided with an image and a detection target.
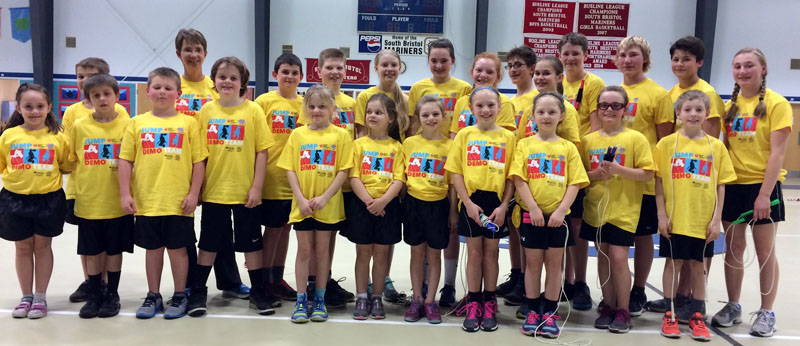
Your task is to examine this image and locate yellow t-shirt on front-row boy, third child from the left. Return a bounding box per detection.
[119,112,208,216]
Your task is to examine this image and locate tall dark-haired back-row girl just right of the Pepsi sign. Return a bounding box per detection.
[407,38,472,137]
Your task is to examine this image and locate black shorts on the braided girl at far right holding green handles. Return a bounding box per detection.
[722,182,786,225]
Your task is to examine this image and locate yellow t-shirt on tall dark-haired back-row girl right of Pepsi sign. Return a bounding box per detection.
[408,77,472,137]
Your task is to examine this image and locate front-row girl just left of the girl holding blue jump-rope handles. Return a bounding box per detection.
[403,95,458,324]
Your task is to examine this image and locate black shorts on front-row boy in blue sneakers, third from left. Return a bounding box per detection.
[133,215,197,250]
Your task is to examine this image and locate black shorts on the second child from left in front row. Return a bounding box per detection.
[78,215,134,256]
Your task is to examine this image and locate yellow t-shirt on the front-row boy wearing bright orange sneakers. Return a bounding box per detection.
[653,132,736,239]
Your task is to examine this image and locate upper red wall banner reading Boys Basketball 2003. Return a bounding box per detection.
[522,0,580,35]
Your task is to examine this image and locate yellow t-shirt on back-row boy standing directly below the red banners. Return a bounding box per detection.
[561,72,606,138]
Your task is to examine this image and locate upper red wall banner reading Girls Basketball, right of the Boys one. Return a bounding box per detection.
[578,2,630,37]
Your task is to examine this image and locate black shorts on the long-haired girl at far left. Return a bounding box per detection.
[0,189,67,241]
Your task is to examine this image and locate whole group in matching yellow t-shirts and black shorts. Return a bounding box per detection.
[0,29,791,340]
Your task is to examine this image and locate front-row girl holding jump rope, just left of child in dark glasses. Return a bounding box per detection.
[509,91,589,338]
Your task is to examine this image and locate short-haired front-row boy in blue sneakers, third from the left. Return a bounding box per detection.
[118,67,208,319]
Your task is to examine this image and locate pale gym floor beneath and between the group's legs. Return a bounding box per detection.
[0,178,800,346]
